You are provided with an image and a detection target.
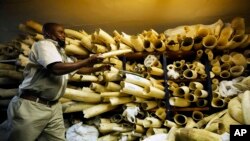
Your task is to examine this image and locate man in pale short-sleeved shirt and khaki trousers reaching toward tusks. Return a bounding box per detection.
[0,23,109,141]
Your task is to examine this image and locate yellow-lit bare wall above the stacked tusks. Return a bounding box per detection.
[0,0,250,42]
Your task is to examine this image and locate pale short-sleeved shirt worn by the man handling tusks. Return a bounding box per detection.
[19,39,68,101]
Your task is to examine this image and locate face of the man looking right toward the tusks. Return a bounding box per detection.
[51,26,65,47]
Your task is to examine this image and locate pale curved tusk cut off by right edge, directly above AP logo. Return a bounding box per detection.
[241,90,250,125]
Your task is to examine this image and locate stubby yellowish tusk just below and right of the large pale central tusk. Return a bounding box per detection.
[144,86,165,99]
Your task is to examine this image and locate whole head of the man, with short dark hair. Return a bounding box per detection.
[43,23,65,47]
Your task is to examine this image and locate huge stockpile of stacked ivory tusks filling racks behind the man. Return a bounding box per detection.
[0,17,250,141]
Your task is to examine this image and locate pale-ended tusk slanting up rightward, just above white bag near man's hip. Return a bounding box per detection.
[83,103,117,118]
